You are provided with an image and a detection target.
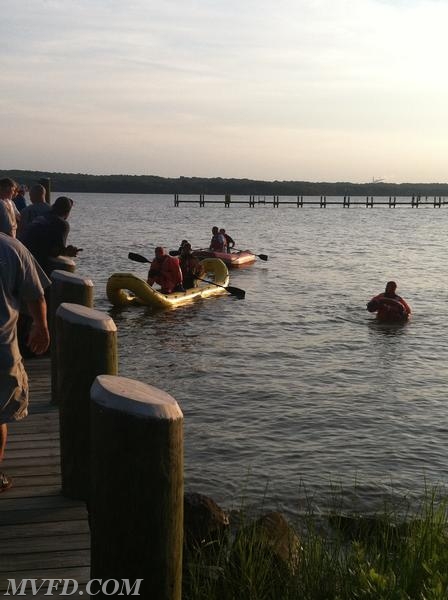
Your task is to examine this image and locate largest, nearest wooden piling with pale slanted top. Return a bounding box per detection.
[89,375,183,600]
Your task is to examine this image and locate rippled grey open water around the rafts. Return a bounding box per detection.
[63,194,448,513]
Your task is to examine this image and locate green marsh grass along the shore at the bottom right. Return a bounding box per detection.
[183,491,448,600]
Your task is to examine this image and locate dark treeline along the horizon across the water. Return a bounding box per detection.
[0,170,448,196]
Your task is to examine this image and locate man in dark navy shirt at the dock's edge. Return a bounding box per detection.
[22,196,80,275]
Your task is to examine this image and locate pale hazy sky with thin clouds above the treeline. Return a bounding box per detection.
[0,0,448,183]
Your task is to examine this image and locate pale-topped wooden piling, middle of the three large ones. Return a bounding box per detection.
[55,302,118,500]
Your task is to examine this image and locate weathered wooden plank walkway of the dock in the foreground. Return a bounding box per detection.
[0,357,90,598]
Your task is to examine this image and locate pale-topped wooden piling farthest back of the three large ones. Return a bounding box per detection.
[48,270,93,404]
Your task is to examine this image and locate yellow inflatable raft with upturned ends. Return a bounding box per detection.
[106,258,229,308]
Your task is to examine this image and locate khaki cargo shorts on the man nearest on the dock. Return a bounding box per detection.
[0,360,28,424]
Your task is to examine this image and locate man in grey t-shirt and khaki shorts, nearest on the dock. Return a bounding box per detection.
[0,233,50,493]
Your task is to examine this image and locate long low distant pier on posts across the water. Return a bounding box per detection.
[174,194,448,208]
